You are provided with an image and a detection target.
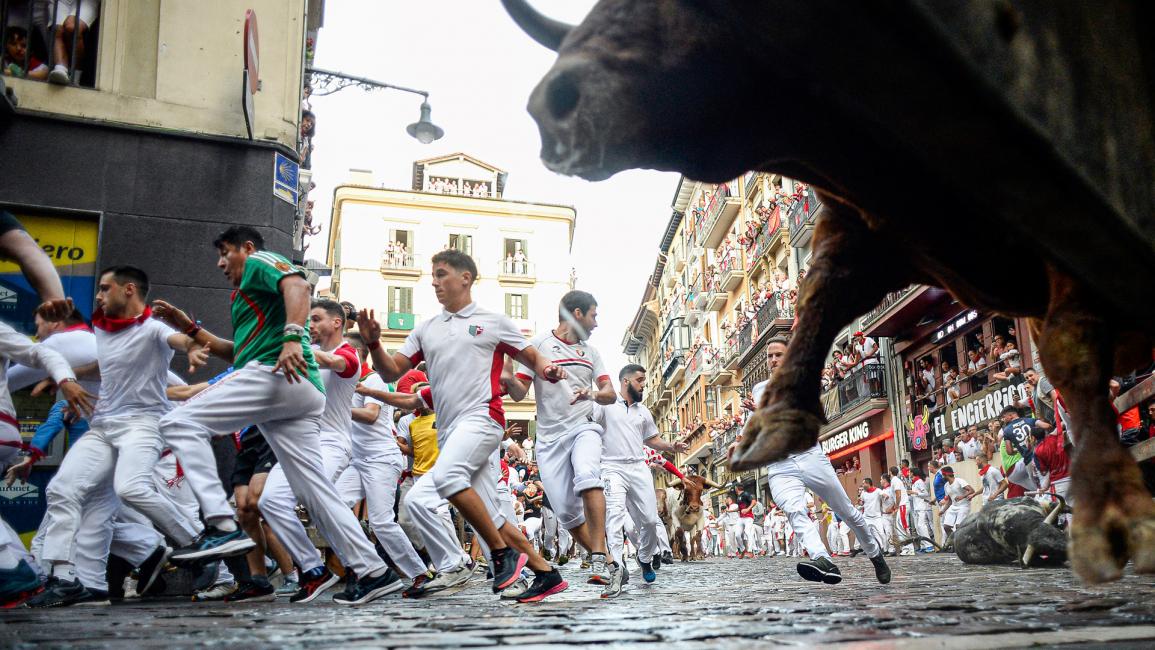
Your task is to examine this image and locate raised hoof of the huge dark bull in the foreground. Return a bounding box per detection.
[730,408,822,471]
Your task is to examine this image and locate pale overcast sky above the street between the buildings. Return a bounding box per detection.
[306,0,678,375]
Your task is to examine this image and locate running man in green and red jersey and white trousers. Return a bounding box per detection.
[156,226,397,604]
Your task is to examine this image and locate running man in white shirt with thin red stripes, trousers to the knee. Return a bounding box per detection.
[501,291,621,584]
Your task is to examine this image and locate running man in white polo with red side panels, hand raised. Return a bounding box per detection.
[357,249,568,603]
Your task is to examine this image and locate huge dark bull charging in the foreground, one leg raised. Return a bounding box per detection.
[502,0,1155,583]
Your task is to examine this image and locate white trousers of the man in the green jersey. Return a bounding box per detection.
[158,361,385,576]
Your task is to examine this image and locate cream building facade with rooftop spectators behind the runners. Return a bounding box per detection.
[328,154,578,433]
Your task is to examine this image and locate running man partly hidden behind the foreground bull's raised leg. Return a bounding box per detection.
[739,336,891,584]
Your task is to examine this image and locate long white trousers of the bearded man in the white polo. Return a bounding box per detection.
[605,461,661,563]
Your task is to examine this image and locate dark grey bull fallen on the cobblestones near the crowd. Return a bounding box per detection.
[954,496,1067,566]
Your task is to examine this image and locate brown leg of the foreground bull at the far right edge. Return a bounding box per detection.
[1040,269,1155,583]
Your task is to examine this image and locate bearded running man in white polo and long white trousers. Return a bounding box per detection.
[593,364,688,598]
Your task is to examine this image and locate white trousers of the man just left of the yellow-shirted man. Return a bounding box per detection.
[353,454,425,578]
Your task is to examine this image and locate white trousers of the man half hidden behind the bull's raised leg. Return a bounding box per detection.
[766,444,881,560]
